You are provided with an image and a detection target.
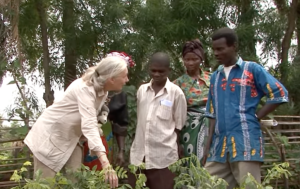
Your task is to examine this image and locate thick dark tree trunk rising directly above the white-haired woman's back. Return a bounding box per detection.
[62,0,77,90]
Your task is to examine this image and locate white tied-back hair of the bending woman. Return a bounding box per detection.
[82,56,127,94]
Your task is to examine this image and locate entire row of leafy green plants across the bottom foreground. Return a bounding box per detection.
[11,155,291,189]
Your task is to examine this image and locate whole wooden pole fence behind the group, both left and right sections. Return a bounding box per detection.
[0,116,300,189]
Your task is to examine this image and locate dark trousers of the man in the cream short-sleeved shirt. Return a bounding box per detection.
[128,168,176,189]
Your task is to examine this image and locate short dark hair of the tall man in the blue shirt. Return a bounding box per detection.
[211,27,238,46]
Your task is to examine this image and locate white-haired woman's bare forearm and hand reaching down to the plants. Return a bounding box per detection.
[97,153,119,188]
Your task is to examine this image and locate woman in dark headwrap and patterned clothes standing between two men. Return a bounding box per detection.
[174,39,210,163]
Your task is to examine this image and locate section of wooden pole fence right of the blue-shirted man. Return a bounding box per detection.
[262,116,300,189]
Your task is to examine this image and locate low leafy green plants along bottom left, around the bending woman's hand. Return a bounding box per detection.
[10,161,150,189]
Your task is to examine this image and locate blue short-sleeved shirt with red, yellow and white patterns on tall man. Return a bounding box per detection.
[205,58,288,163]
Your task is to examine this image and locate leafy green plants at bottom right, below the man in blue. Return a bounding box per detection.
[169,155,291,189]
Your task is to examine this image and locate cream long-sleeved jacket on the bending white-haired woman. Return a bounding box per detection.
[24,79,107,172]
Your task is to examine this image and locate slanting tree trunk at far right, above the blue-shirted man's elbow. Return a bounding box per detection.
[279,0,298,84]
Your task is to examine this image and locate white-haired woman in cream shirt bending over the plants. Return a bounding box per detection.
[24,52,132,188]
